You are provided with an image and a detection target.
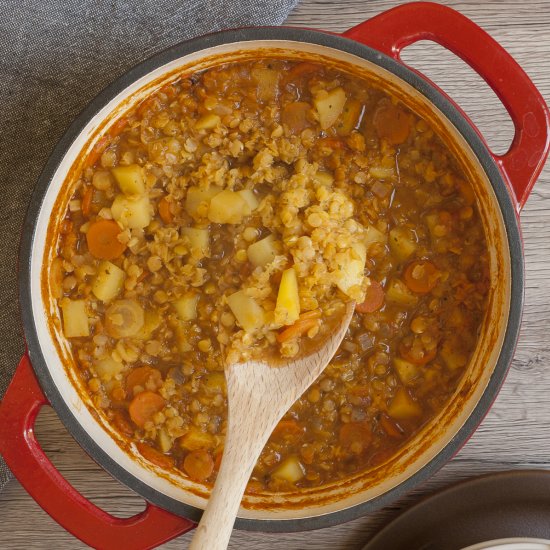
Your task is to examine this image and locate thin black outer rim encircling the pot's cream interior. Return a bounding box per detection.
[19,27,524,532]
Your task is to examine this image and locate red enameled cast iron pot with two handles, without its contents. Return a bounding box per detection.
[0,3,549,549]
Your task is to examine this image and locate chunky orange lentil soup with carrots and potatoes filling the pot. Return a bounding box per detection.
[50,59,489,492]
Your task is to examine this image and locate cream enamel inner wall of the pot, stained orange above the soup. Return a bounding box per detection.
[31,41,510,520]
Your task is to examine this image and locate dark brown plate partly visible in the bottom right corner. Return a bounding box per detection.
[364,470,550,550]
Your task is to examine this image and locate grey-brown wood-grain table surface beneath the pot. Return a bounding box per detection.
[0,0,550,550]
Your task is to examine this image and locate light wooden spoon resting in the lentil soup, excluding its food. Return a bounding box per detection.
[189,302,355,550]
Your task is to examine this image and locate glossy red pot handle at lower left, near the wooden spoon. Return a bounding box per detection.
[0,355,195,550]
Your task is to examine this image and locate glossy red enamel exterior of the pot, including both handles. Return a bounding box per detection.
[0,2,550,549]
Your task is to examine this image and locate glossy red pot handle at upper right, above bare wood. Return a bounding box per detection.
[343,2,550,212]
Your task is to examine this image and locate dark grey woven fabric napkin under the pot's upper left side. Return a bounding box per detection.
[0,0,298,489]
